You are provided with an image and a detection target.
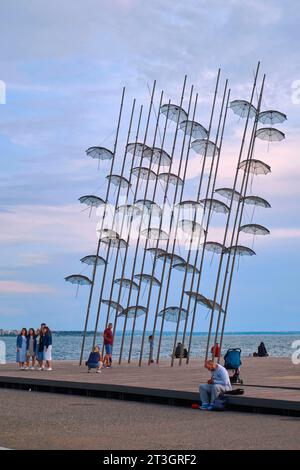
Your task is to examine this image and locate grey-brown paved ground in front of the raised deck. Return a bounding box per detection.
[0,389,300,450]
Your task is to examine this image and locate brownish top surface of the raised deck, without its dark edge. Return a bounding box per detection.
[0,357,300,401]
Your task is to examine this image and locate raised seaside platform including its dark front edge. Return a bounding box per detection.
[0,358,300,416]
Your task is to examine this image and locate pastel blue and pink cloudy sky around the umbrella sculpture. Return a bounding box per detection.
[0,0,300,331]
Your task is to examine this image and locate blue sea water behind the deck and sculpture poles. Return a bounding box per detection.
[0,332,300,362]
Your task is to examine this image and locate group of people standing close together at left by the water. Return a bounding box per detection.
[16,323,52,371]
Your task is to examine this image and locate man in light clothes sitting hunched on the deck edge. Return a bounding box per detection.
[199,361,232,410]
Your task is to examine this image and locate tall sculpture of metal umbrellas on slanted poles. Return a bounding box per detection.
[65,65,287,365]
